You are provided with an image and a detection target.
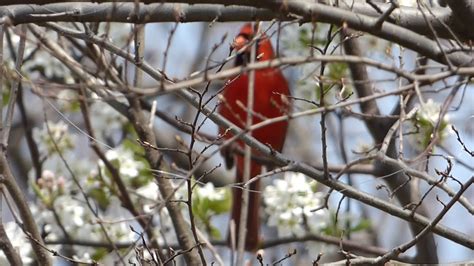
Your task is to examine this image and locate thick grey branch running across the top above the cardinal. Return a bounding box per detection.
[0,0,474,56]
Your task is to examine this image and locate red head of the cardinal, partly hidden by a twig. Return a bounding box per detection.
[231,23,274,66]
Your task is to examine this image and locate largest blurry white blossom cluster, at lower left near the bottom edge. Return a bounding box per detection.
[30,170,137,262]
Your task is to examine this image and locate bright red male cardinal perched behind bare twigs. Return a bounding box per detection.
[219,23,290,251]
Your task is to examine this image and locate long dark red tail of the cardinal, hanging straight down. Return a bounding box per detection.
[229,156,262,251]
